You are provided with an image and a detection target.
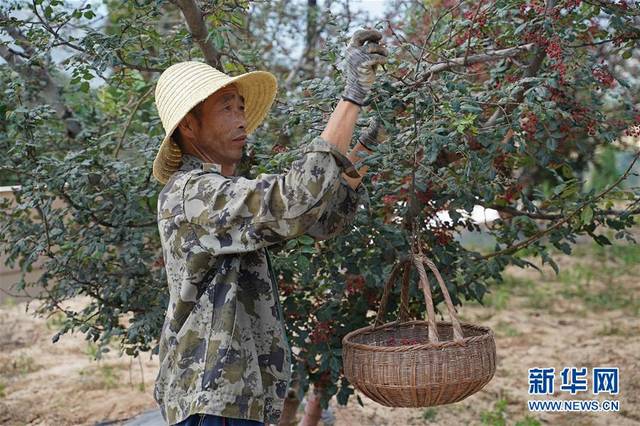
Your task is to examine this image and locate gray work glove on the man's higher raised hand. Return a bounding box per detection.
[342,29,388,106]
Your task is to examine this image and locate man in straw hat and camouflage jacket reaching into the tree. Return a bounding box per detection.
[153,30,387,425]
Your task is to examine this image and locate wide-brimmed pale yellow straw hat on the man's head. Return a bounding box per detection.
[153,61,278,185]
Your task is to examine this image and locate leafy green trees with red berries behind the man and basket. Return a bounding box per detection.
[0,0,640,422]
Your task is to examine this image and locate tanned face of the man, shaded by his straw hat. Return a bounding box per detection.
[193,85,247,165]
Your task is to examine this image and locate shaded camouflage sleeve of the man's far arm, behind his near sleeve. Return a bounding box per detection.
[306,176,370,240]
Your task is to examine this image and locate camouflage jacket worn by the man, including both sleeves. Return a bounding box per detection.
[154,137,369,424]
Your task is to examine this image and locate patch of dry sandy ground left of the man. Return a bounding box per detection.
[0,299,157,426]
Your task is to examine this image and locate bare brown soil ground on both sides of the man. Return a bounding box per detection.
[0,241,640,426]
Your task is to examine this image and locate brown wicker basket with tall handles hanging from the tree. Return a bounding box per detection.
[342,253,496,407]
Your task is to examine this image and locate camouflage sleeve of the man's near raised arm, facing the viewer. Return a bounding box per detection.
[182,137,358,255]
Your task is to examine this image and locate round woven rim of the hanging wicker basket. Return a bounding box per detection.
[342,320,495,352]
